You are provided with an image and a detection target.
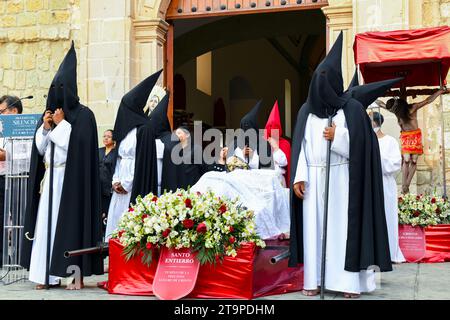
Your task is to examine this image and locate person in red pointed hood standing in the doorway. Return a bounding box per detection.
[264,101,291,186]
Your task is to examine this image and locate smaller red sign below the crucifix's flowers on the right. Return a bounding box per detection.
[398,225,426,262]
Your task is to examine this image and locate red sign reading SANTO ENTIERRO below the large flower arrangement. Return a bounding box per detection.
[153,247,200,300]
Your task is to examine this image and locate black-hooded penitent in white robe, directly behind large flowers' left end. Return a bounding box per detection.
[105,70,162,238]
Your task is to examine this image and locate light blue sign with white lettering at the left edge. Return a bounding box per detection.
[0,114,42,138]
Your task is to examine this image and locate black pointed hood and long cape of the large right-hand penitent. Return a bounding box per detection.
[289,34,397,272]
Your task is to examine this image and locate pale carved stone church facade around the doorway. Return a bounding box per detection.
[0,0,450,192]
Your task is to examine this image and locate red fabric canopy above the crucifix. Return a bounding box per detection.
[353,26,450,87]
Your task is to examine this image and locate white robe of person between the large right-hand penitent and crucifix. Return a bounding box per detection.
[378,135,405,262]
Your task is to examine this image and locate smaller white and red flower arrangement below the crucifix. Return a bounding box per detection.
[398,193,450,227]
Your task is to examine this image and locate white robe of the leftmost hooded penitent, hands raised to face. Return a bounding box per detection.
[29,120,72,285]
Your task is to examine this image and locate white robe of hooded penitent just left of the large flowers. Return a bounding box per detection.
[105,128,137,240]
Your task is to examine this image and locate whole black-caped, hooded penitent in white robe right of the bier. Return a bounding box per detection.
[289,33,396,295]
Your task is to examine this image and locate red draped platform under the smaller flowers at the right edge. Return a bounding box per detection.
[421,224,450,262]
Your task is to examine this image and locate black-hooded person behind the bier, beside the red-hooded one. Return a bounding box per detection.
[229,100,273,169]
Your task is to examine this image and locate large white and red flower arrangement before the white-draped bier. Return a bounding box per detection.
[112,189,265,265]
